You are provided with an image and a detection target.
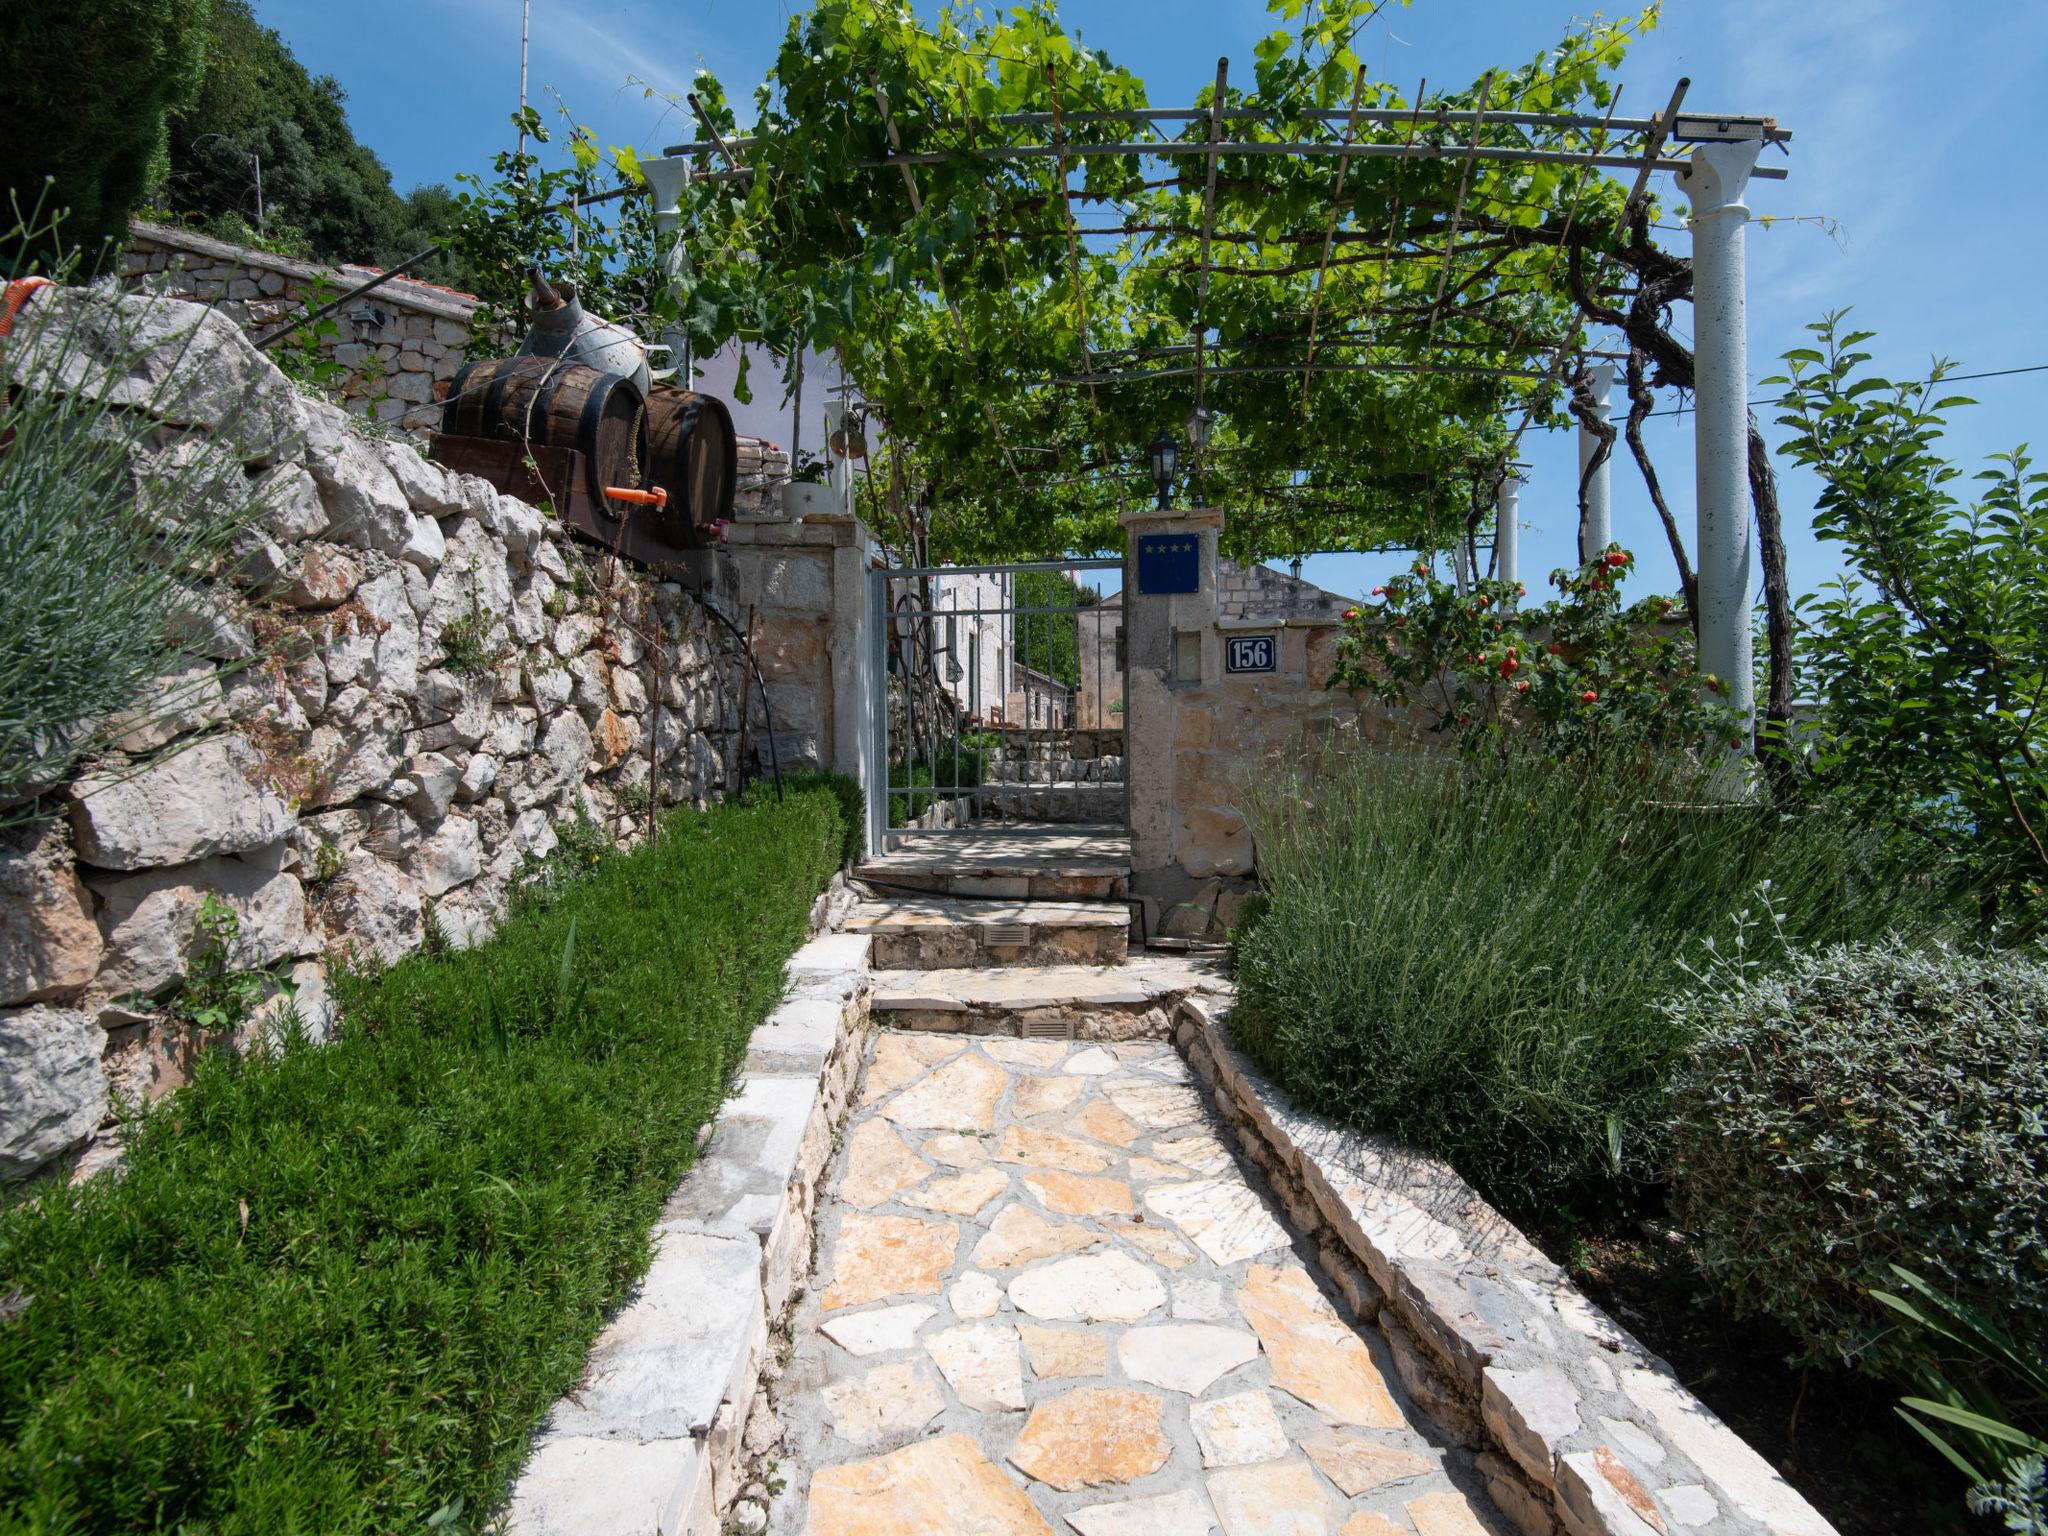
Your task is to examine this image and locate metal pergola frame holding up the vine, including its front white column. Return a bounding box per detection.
[666,59,1792,737]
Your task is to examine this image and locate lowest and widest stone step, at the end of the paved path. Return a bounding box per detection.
[872,950,1231,1040]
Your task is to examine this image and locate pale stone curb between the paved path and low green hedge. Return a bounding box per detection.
[506,921,870,1536]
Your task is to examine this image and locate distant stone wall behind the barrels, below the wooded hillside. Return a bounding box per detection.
[123,219,483,428]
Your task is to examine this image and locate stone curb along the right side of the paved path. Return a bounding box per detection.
[1174,997,1835,1536]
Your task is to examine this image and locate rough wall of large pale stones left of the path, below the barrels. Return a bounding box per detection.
[0,289,774,1178]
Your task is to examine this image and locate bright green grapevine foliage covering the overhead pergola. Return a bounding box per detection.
[440,0,1655,559]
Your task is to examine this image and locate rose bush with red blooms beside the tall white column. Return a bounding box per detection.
[1329,547,1735,758]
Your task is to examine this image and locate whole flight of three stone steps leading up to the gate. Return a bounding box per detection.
[846,823,1227,1040]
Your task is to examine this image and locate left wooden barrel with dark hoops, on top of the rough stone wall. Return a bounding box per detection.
[440,356,647,516]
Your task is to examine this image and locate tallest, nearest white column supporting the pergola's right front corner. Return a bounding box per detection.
[1677,139,1763,729]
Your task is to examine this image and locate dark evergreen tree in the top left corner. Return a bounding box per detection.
[0,0,209,266]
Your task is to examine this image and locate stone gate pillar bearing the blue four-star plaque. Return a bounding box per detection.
[1122,508,1223,915]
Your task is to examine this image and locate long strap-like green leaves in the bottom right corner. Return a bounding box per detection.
[1872,1264,2048,1536]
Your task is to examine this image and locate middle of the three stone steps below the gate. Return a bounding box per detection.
[846,895,1130,971]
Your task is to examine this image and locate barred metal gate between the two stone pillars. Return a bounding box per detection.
[868,559,1126,852]
